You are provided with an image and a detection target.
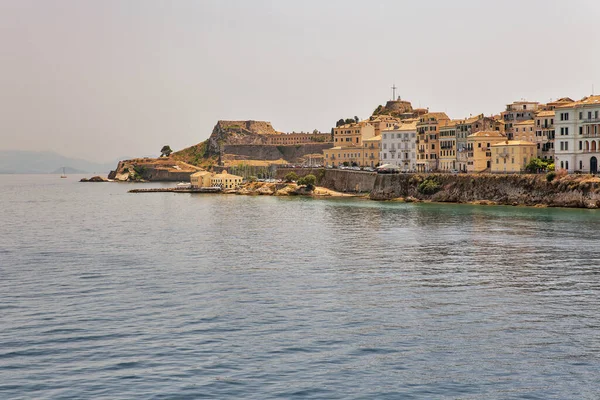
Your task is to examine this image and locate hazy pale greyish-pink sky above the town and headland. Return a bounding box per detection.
[0,0,600,162]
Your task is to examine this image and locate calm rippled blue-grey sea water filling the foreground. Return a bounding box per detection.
[0,175,600,399]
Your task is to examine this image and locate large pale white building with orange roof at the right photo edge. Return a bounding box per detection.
[554,96,600,173]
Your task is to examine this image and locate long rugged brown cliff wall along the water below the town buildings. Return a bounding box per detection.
[277,168,600,209]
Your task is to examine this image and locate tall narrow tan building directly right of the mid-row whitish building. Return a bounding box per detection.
[416,112,450,172]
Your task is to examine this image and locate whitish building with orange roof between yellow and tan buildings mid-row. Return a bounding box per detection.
[379,119,417,171]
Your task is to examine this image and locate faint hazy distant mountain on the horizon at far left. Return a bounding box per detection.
[0,150,117,174]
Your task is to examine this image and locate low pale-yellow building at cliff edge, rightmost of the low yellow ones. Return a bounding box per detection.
[491,140,537,173]
